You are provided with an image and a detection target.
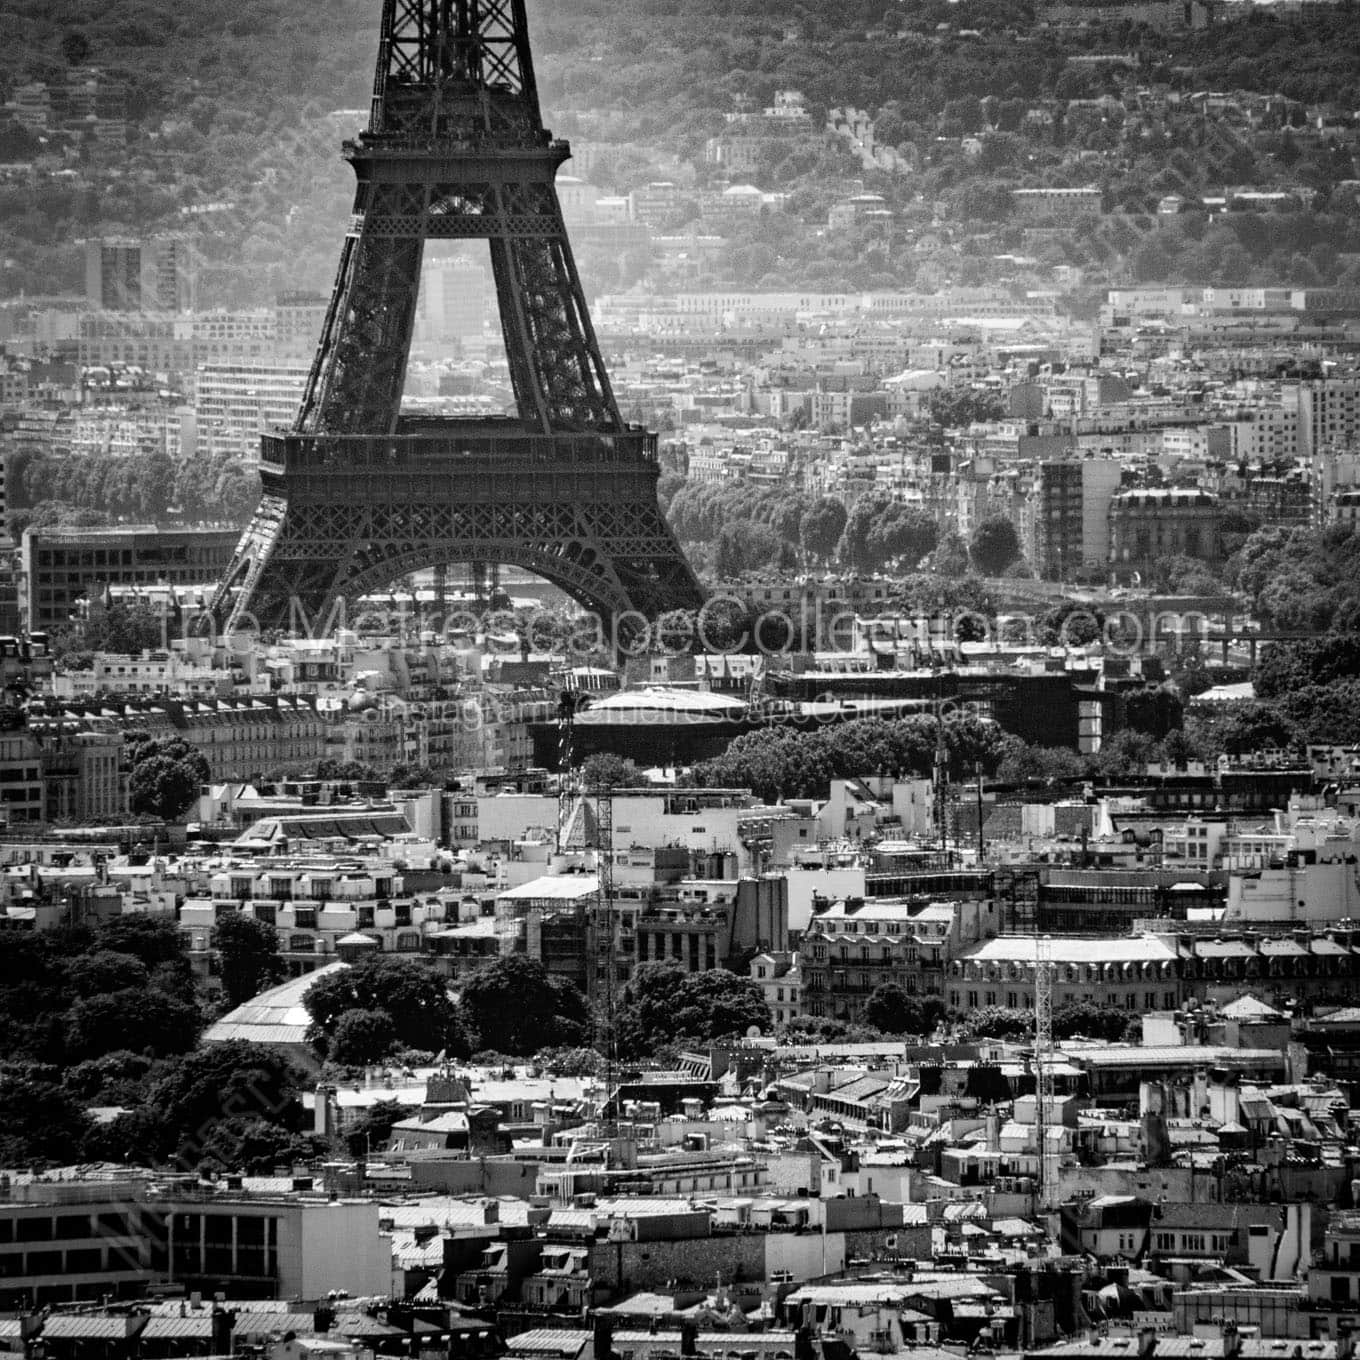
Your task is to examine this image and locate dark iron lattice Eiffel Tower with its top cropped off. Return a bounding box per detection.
[211,0,703,631]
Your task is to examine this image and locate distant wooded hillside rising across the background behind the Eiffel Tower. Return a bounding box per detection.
[0,0,1360,306]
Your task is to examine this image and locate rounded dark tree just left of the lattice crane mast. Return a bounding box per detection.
[458,953,590,1057]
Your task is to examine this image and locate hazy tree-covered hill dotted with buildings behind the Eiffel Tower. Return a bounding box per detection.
[0,0,1360,306]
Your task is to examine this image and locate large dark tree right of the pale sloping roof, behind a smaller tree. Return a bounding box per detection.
[302,955,466,1053]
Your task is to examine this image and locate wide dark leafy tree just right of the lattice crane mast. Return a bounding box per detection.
[617,963,771,1057]
